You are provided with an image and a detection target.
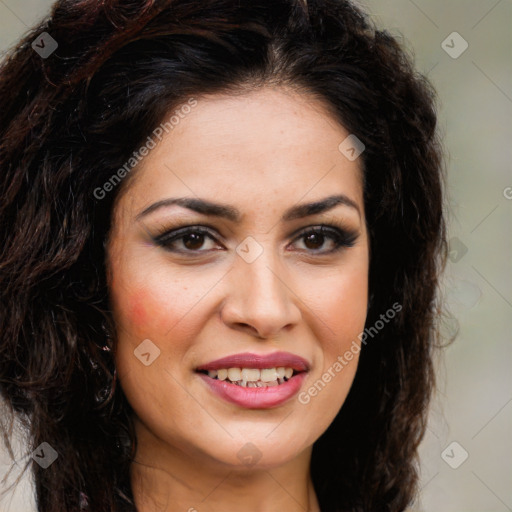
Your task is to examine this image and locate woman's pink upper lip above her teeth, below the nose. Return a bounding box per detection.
[197,352,309,372]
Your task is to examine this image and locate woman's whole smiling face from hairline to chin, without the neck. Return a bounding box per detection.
[108,88,368,467]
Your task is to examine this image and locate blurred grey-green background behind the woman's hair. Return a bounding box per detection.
[0,0,512,512]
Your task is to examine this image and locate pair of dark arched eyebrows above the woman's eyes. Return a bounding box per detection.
[135,194,361,222]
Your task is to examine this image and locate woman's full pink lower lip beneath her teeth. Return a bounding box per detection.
[198,372,306,409]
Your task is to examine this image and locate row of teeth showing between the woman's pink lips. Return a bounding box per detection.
[198,366,303,388]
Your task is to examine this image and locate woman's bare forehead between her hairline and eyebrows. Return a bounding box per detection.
[117,88,363,222]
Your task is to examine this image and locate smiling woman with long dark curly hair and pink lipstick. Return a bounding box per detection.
[0,0,445,512]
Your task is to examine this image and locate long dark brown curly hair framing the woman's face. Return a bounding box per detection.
[0,0,446,512]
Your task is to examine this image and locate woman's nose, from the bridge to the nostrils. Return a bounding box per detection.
[221,249,301,339]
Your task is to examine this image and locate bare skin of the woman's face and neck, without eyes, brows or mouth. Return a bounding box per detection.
[107,87,369,512]
